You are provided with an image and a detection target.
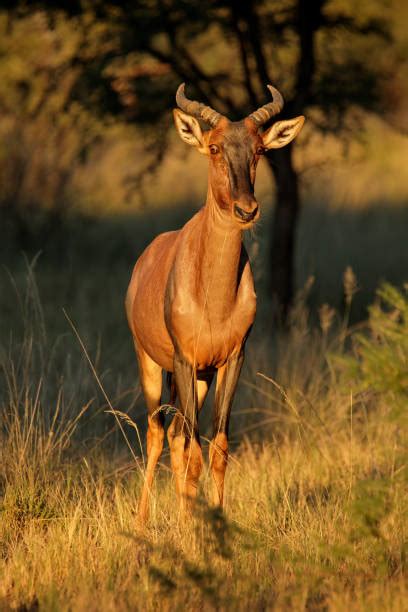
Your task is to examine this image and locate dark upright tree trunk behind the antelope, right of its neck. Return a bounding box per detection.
[267,145,300,323]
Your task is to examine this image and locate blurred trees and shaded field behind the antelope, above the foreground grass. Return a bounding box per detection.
[0,0,408,430]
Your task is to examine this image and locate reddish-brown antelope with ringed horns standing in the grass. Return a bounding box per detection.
[126,83,304,523]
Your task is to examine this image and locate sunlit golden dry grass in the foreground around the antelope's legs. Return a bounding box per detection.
[0,260,408,611]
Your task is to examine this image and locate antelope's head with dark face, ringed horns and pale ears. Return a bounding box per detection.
[173,83,305,229]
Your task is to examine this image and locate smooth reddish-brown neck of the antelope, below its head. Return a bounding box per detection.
[197,190,242,321]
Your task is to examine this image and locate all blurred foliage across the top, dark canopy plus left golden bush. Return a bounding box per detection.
[0,0,402,220]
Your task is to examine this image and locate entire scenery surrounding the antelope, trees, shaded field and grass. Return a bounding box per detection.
[0,0,408,612]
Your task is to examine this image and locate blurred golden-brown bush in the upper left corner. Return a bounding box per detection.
[0,8,122,238]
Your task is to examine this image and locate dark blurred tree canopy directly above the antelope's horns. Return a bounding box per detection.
[66,0,393,134]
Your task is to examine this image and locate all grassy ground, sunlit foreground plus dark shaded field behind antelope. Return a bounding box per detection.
[0,208,408,611]
